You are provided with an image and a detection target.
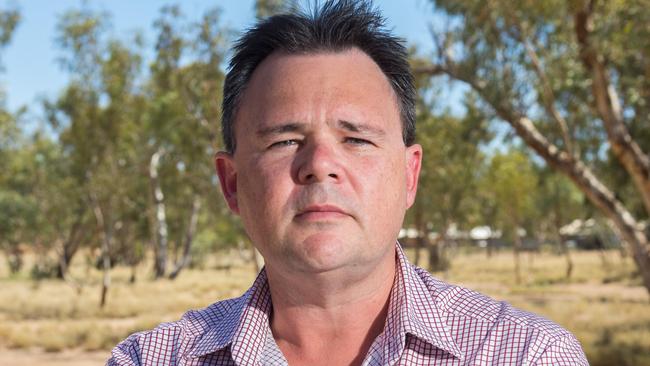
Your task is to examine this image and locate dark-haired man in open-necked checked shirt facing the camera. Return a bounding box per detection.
[108,1,587,365]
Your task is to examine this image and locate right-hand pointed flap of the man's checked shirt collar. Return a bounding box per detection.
[383,243,464,364]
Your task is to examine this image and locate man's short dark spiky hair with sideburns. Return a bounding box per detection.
[221,0,415,153]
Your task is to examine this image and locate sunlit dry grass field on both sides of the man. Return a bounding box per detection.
[0,247,650,365]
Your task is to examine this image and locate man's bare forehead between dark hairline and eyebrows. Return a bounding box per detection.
[239,49,399,124]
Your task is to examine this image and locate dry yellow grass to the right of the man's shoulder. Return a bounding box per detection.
[428,251,650,366]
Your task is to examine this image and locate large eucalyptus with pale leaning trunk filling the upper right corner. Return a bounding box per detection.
[418,0,650,291]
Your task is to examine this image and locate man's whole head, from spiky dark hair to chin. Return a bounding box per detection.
[216,1,421,276]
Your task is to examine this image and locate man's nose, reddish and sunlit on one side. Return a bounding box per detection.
[296,142,341,184]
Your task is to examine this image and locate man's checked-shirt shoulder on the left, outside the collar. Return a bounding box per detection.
[107,296,245,366]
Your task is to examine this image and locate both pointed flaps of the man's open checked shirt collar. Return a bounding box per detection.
[189,243,464,364]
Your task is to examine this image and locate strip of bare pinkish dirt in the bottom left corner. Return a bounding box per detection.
[0,349,109,366]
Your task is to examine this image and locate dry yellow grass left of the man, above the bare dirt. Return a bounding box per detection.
[0,249,255,352]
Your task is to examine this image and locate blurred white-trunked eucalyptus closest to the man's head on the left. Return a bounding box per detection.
[143,6,228,278]
